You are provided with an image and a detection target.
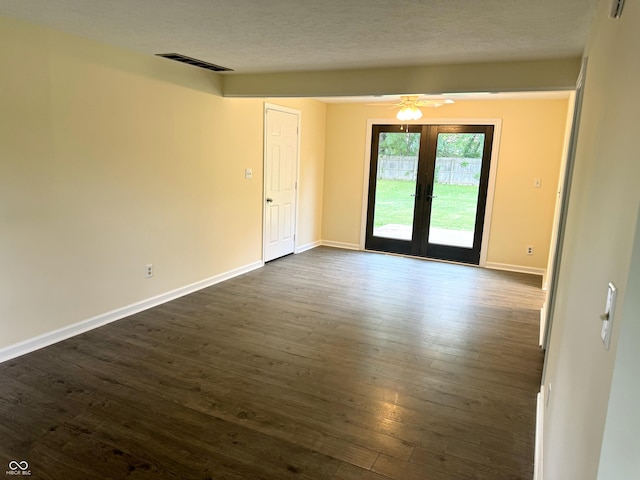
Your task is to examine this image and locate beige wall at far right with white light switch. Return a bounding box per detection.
[544,2,640,480]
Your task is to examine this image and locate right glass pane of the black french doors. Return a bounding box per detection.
[428,133,485,248]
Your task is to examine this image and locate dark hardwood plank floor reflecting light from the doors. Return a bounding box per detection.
[0,248,543,480]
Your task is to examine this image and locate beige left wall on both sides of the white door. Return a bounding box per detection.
[0,17,325,348]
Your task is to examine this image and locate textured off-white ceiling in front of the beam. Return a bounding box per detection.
[0,0,604,73]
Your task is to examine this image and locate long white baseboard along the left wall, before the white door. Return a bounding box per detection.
[0,261,264,363]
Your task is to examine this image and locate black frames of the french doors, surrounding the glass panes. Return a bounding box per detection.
[362,119,500,265]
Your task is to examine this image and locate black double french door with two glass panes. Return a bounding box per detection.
[365,125,493,265]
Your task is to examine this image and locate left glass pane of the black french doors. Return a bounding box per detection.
[373,132,420,241]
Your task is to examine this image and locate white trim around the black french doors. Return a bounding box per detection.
[360,118,502,267]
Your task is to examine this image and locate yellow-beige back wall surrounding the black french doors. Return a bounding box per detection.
[323,99,568,269]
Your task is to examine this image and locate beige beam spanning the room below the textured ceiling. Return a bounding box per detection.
[223,58,580,97]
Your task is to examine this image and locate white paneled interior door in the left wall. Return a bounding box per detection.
[264,105,300,262]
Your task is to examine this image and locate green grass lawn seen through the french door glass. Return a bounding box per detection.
[374,180,478,232]
